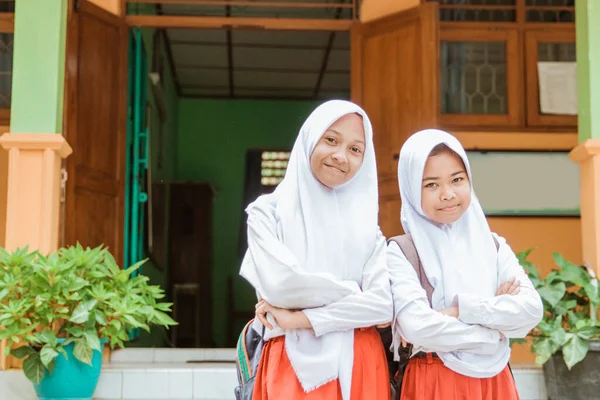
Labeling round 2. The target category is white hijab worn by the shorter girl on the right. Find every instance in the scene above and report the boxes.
[398,129,510,373]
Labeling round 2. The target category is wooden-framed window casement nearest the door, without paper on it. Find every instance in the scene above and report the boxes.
[440,29,520,126]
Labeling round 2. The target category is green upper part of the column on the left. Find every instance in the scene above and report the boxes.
[10,0,68,133]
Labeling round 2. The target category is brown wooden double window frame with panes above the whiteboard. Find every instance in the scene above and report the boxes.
[437,0,577,129]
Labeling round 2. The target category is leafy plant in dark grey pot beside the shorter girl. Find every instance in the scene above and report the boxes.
[517,250,600,400]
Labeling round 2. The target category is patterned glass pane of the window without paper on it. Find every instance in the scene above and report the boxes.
[440,41,507,114]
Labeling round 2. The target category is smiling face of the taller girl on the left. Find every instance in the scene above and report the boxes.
[310,114,365,188]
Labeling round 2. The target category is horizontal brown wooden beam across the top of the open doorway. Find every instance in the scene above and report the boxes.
[125,15,354,32]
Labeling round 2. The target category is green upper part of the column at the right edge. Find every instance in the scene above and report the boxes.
[575,0,600,143]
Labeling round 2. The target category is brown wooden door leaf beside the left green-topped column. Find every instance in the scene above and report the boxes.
[64,0,128,264]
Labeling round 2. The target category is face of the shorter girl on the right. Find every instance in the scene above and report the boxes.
[421,145,471,224]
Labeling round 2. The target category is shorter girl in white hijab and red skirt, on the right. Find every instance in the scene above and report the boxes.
[388,129,543,400]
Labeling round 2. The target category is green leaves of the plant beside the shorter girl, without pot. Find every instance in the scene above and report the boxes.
[517,249,600,369]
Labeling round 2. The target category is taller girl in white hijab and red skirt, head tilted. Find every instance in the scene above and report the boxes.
[240,100,392,400]
